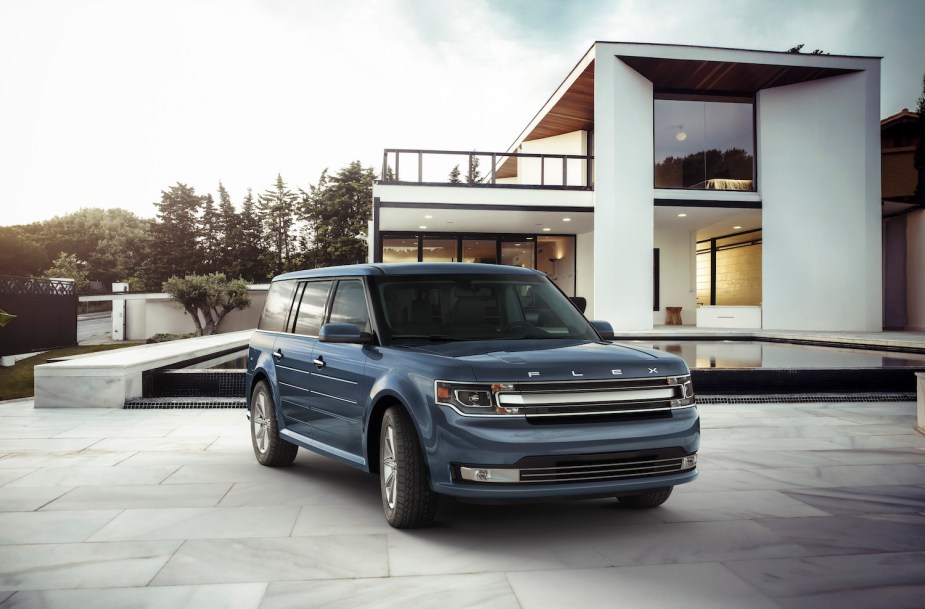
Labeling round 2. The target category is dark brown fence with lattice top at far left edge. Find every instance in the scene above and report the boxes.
[0,275,77,355]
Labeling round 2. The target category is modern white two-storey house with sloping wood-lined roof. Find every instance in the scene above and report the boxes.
[369,42,883,331]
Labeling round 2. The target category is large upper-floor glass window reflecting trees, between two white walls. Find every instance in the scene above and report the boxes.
[654,96,755,191]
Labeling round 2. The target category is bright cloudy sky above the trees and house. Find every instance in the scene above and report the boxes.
[0,0,925,226]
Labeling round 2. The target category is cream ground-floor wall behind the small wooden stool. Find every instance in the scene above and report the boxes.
[652,229,697,326]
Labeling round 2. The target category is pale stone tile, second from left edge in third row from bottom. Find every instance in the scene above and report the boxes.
[90,507,299,541]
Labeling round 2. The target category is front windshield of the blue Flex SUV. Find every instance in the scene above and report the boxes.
[374,275,598,341]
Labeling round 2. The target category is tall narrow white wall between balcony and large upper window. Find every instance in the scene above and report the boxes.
[594,50,654,330]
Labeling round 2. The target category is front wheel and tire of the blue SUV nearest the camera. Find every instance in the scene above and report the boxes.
[379,406,437,529]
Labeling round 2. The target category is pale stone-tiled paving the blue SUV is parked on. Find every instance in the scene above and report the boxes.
[0,401,925,609]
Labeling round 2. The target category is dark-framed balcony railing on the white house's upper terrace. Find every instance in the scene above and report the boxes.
[379,148,594,190]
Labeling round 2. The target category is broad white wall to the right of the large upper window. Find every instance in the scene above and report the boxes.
[757,67,882,331]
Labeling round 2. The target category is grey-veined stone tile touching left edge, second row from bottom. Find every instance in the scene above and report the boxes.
[0,541,180,590]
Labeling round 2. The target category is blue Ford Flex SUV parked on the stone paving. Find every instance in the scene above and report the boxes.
[247,263,700,528]
